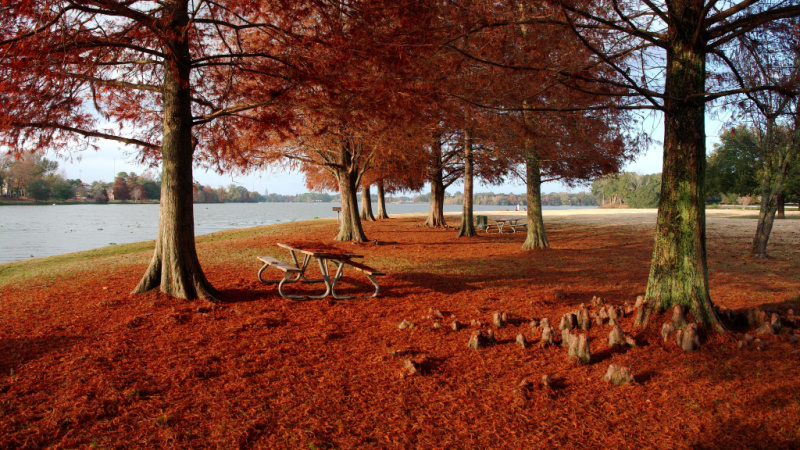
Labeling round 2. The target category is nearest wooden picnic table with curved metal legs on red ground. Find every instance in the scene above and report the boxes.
[257,243,386,299]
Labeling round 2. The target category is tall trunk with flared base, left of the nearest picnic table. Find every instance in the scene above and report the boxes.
[133,0,218,300]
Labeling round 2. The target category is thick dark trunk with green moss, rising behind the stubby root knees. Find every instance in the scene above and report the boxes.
[642,0,723,330]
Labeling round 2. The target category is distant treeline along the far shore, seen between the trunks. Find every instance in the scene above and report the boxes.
[0,151,800,210]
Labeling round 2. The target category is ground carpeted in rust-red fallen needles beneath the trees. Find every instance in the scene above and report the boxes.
[0,216,800,448]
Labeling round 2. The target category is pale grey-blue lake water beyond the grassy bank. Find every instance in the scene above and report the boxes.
[0,203,594,264]
